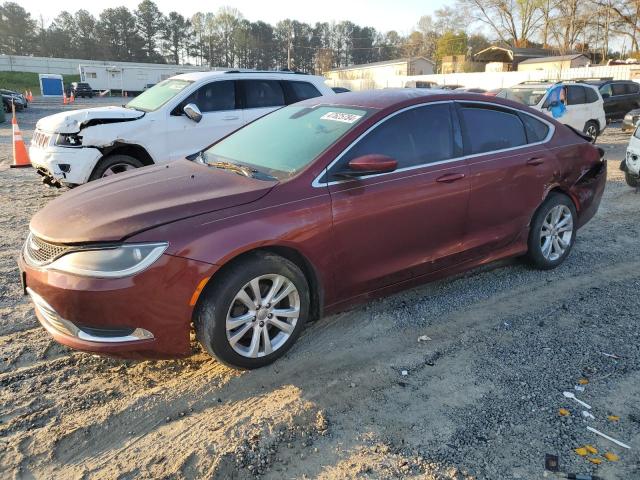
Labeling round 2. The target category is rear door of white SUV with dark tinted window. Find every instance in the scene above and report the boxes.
[238,78,286,124]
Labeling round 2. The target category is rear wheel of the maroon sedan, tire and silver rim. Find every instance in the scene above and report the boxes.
[527,192,578,270]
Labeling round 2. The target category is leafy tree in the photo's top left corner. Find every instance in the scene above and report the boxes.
[0,2,36,55]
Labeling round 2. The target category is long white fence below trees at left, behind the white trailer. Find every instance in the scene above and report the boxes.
[0,55,204,75]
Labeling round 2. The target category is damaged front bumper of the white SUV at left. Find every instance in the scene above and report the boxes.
[29,145,102,186]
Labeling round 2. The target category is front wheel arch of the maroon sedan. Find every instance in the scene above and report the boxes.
[194,245,324,322]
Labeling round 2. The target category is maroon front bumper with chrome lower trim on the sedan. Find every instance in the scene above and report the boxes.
[18,254,217,359]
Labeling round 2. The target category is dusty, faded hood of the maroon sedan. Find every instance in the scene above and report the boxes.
[30,160,278,244]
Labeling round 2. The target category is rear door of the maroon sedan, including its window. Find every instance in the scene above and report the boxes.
[458,102,558,258]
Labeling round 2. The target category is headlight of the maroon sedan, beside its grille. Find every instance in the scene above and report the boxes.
[48,242,169,278]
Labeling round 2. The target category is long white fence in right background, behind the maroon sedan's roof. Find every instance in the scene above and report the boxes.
[327,65,640,91]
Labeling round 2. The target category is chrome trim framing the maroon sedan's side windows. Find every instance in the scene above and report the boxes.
[311,100,556,188]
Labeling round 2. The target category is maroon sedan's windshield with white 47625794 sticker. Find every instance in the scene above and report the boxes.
[202,105,369,178]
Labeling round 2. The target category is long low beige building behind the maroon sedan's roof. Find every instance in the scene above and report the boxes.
[324,57,435,80]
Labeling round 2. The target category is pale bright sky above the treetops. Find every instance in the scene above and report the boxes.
[20,0,452,34]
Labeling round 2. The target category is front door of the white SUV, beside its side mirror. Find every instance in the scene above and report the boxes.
[166,80,242,160]
